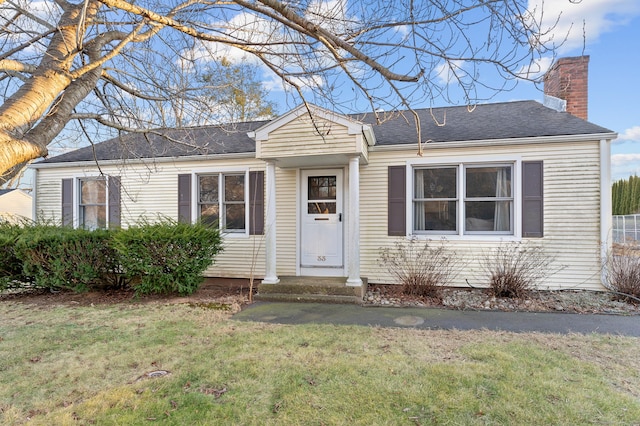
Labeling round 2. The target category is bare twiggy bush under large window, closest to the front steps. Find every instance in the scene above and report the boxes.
[379,238,461,298]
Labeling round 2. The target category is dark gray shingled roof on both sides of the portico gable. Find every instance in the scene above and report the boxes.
[40,101,612,164]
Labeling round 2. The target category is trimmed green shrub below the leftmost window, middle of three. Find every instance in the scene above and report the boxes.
[17,224,119,292]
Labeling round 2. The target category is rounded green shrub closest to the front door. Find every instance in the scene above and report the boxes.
[113,218,222,295]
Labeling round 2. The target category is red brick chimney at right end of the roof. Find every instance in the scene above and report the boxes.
[544,56,589,120]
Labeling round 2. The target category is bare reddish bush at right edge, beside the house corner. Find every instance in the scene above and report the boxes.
[605,243,640,305]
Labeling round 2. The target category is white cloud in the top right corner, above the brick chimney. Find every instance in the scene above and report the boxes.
[528,0,640,55]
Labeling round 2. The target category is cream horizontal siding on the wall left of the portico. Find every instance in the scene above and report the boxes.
[36,159,265,278]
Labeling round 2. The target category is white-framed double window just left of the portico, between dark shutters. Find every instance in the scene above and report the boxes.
[198,173,246,232]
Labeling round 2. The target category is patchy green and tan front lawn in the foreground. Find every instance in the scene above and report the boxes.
[0,302,640,425]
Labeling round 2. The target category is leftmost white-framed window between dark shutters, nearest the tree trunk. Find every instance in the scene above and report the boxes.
[78,177,107,229]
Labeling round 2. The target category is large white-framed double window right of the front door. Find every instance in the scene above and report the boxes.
[413,164,514,235]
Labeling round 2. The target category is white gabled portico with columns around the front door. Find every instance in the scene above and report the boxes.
[249,105,375,287]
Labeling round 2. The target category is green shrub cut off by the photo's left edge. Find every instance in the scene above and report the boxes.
[0,221,33,291]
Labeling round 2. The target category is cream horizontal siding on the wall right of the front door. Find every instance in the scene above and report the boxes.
[360,141,602,290]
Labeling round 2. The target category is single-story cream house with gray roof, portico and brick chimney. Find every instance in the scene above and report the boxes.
[28,57,616,290]
